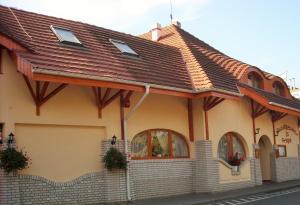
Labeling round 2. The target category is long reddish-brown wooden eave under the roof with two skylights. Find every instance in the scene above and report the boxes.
[0,34,240,100]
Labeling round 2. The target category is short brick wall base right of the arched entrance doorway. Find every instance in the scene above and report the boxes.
[271,156,300,182]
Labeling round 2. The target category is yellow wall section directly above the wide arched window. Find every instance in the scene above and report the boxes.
[125,94,194,156]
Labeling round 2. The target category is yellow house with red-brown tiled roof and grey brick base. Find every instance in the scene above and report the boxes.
[0,6,300,204]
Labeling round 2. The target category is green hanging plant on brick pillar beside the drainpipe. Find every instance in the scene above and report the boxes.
[103,147,127,171]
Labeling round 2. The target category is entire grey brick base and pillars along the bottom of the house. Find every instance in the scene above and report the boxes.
[0,140,300,205]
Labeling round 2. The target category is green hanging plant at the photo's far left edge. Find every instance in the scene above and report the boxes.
[0,148,29,174]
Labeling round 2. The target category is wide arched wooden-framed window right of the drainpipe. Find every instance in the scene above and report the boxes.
[131,129,189,159]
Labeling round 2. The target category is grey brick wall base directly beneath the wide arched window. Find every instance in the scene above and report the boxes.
[130,159,193,199]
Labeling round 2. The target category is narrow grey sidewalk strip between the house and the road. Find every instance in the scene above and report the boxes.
[127,180,300,205]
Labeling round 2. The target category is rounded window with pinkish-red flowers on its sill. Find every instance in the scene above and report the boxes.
[218,132,246,166]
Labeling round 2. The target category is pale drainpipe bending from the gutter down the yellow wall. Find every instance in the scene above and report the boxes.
[123,85,150,201]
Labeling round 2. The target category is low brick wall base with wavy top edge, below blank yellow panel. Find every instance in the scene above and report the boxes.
[18,172,105,204]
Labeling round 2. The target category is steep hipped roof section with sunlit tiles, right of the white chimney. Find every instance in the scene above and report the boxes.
[140,25,252,92]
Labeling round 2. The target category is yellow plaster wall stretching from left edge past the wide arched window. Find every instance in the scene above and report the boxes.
[0,52,193,181]
